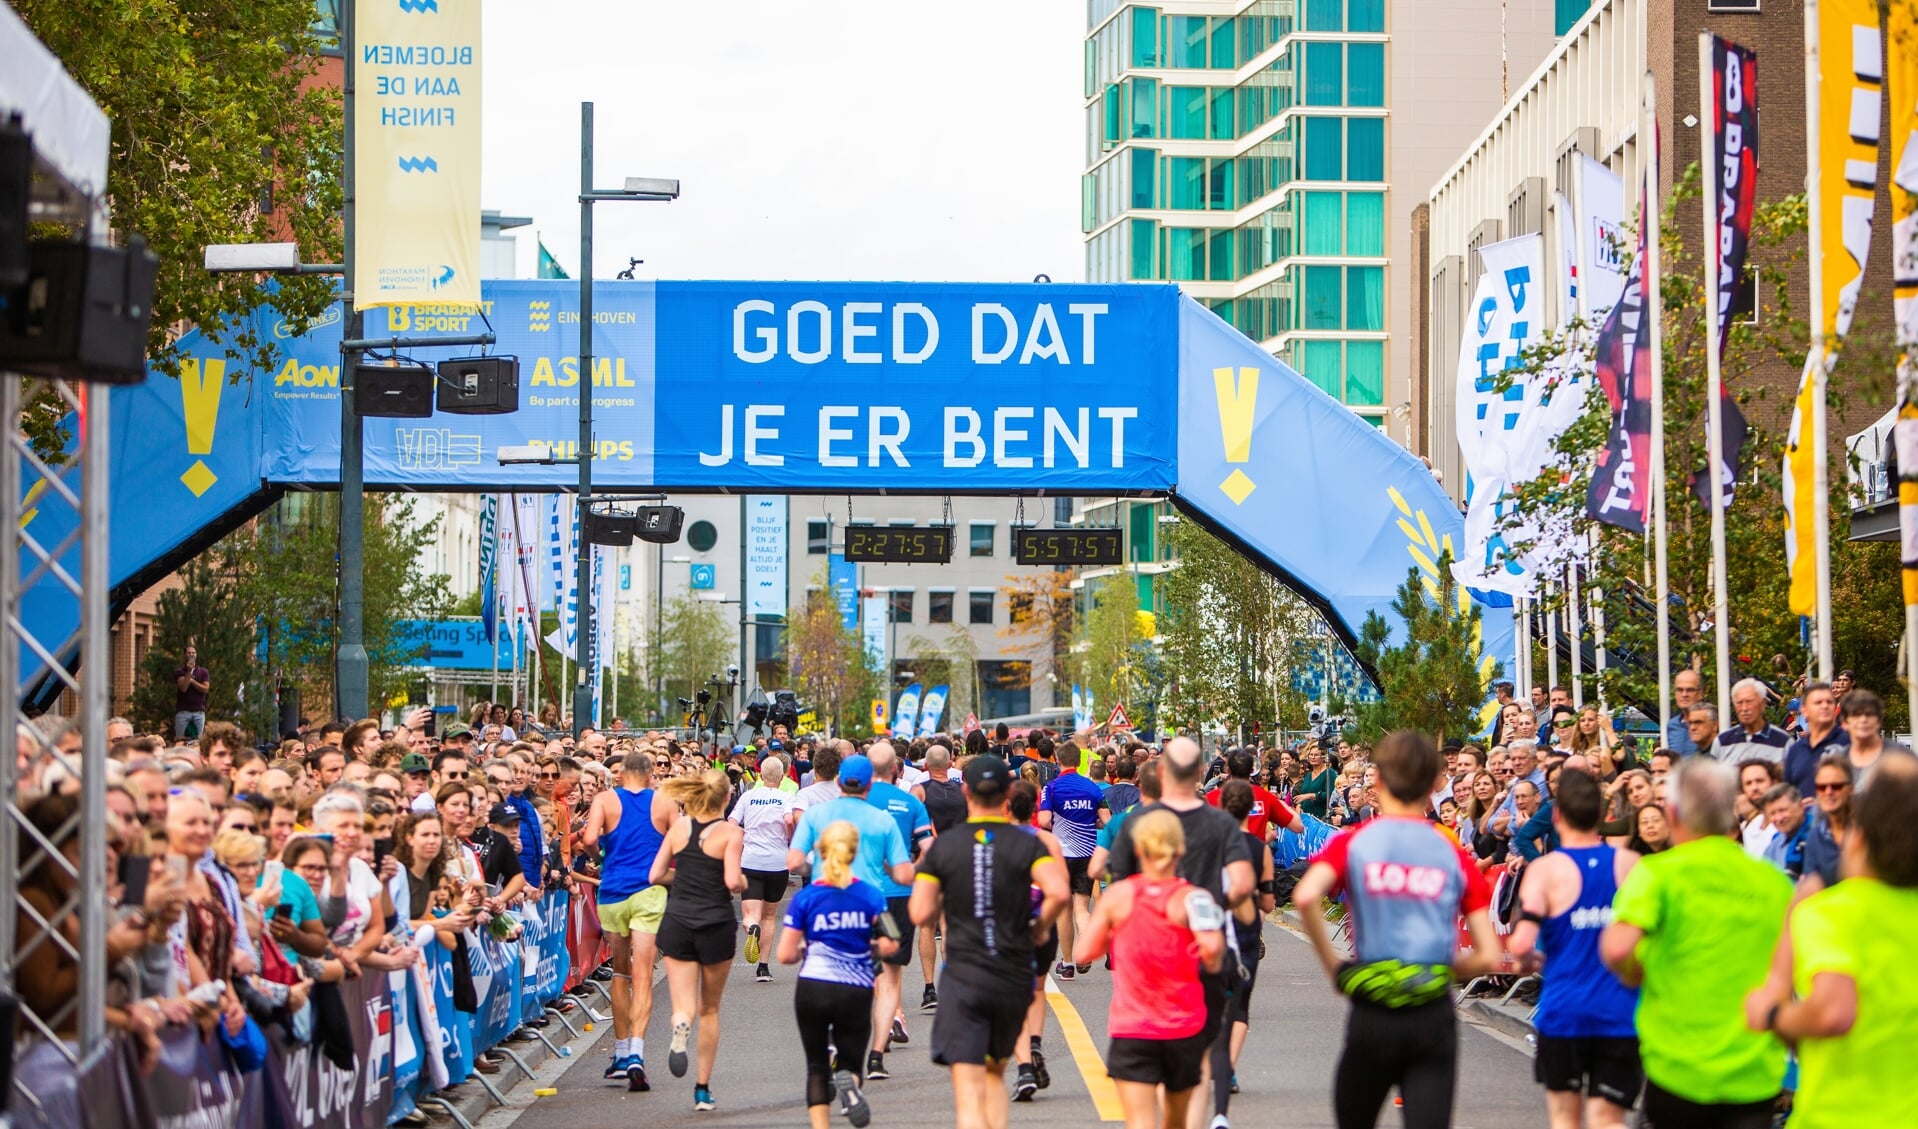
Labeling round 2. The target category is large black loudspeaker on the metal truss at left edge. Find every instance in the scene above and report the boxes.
[0,238,159,383]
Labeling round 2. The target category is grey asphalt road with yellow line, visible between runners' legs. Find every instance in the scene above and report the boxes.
[481,924,1544,1129]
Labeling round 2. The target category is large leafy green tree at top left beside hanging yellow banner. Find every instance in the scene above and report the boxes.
[13,0,343,380]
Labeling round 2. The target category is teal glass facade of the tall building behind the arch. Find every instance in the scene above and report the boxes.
[1080,0,1391,416]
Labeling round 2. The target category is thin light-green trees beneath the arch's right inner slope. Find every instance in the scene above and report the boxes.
[1160,521,1323,732]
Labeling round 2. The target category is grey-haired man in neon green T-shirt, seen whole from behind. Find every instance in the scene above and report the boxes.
[1600,757,1791,1129]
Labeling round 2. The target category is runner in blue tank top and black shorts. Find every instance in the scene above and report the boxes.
[1509,761,1644,1129]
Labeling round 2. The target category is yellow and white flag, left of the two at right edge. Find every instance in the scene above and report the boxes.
[1784,0,1897,615]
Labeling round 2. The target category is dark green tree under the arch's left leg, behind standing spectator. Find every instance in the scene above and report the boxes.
[129,558,258,734]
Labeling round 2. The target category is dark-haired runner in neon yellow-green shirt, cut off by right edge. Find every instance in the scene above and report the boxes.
[1745,759,1918,1129]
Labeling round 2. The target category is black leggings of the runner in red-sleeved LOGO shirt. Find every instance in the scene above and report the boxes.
[1331,997,1458,1129]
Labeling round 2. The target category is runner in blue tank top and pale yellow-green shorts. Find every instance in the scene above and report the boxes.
[585,753,673,1091]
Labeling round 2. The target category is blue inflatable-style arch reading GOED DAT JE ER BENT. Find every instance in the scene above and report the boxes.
[23,280,1513,705]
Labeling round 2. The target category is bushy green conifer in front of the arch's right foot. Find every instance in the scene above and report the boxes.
[1354,554,1504,740]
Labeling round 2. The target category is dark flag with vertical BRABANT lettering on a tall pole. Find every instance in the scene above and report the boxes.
[1694,35,1759,506]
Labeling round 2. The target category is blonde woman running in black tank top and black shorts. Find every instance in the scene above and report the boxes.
[652,771,746,1110]
